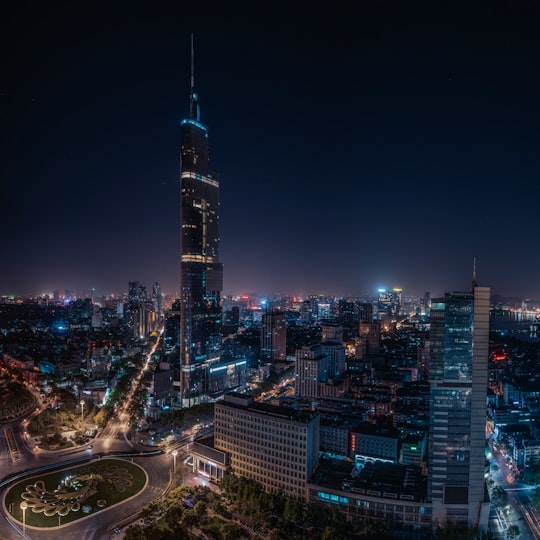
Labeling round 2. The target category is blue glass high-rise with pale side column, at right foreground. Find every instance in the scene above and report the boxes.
[428,282,490,528]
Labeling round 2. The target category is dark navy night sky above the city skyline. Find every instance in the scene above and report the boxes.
[0,1,540,299]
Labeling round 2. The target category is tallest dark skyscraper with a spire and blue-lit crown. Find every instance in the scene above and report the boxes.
[178,37,223,406]
